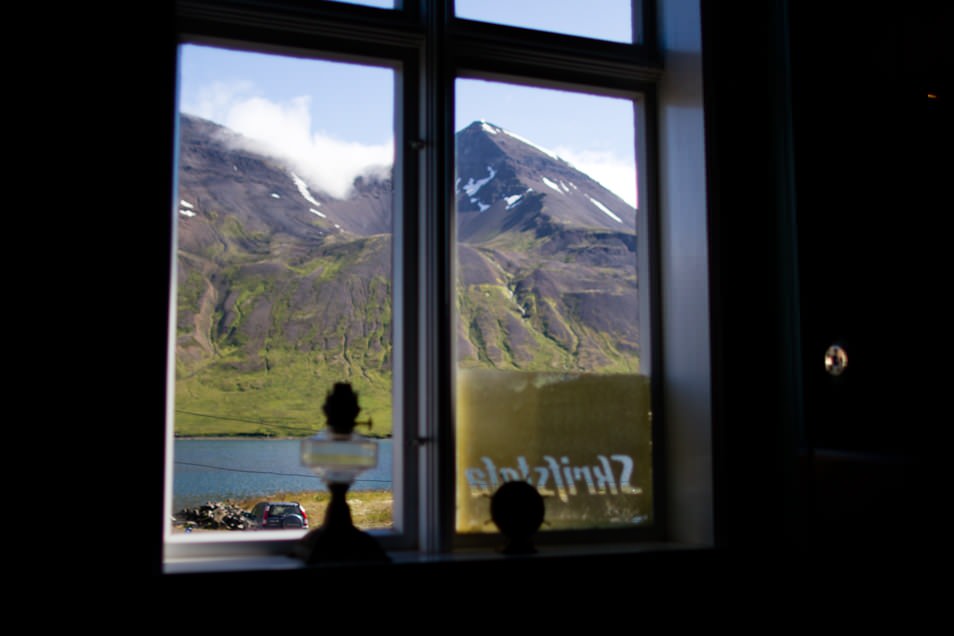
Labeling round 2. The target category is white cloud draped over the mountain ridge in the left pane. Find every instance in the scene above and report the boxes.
[183,83,394,198]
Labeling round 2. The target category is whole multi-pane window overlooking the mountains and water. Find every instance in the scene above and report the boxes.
[166,0,711,563]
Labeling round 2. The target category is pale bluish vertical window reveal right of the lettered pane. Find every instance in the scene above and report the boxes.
[658,0,715,545]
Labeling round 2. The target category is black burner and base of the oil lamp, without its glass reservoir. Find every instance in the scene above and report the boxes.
[294,382,391,565]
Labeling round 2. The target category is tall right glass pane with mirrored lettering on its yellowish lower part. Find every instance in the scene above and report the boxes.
[456,79,653,533]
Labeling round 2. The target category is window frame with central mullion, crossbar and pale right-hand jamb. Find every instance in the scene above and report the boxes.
[163,0,714,573]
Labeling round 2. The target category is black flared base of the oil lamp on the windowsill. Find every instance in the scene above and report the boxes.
[295,484,391,565]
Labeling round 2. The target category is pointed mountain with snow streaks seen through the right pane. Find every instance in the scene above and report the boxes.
[456,122,639,371]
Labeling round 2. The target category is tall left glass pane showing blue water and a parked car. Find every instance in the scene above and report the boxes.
[167,45,395,535]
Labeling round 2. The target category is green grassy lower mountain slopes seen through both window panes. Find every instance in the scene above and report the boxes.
[175,211,638,437]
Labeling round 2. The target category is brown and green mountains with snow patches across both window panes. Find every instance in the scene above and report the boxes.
[176,115,639,434]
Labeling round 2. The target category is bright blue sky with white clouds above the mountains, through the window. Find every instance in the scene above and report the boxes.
[179,0,637,207]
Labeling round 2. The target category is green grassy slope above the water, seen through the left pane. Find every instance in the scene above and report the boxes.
[175,232,391,437]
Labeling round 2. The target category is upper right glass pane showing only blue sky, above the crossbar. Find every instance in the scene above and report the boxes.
[454,0,633,43]
